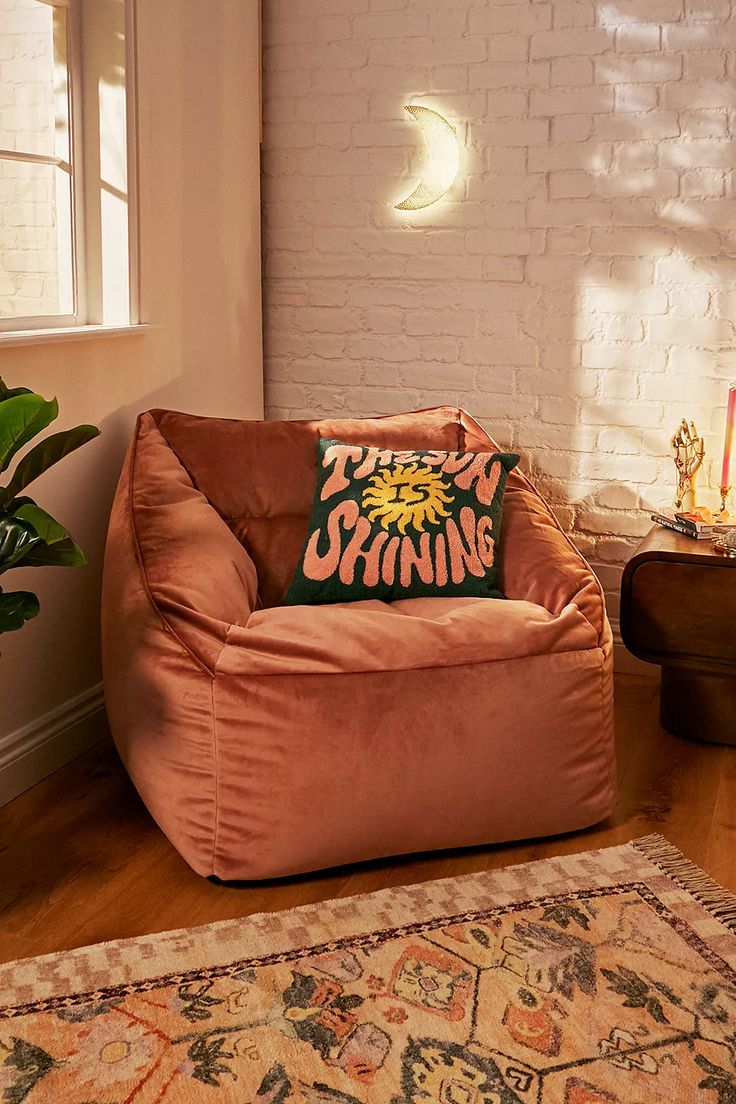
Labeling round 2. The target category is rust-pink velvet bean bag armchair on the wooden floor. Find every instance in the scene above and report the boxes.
[103,407,616,879]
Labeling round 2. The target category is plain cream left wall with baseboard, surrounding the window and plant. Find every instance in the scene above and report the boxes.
[0,0,263,804]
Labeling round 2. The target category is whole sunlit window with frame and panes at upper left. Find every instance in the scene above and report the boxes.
[0,0,137,331]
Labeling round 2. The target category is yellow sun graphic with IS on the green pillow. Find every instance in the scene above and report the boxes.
[362,464,454,535]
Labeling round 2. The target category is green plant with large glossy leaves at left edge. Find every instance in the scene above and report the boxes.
[0,378,99,633]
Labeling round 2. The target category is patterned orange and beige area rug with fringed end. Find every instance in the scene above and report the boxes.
[0,836,736,1104]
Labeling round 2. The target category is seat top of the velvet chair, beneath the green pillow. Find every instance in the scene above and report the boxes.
[218,597,598,675]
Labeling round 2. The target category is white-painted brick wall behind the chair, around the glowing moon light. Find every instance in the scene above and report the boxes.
[264,0,736,617]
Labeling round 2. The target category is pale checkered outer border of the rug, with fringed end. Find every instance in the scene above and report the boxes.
[0,835,736,1020]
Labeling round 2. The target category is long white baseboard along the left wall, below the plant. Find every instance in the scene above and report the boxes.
[0,682,107,805]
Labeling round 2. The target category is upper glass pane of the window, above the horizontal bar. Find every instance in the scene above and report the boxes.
[0,0,70,161]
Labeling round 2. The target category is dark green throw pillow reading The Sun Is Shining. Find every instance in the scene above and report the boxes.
[286,438,519,605]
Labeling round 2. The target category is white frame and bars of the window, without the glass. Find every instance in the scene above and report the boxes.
[0,0,141,333]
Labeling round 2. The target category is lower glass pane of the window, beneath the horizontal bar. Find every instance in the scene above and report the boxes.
[0,158,74,318]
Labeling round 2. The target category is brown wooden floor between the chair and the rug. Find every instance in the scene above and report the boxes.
[0,676,736,962]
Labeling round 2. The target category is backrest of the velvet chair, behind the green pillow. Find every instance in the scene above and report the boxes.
[150,406,481,606]
